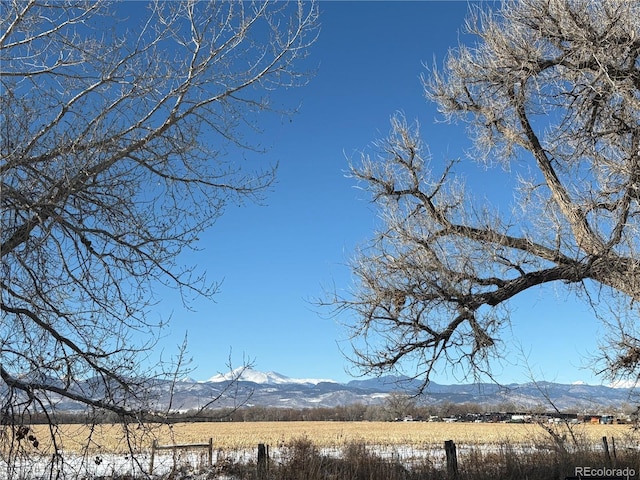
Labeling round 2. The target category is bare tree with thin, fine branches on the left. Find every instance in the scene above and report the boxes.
[0,0,318,472]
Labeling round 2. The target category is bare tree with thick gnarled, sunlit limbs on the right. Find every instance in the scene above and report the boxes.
[338,0,640,390]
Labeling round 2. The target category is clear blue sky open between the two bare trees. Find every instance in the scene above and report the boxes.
[152,1,601,383]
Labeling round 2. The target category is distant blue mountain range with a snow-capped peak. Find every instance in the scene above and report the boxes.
[158,369,638,411]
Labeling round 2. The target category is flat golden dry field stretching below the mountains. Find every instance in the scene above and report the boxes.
[26,422,638,453]
